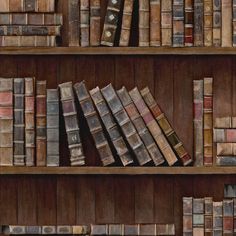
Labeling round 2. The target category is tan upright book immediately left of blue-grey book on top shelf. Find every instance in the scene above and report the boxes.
[161,0,172,46]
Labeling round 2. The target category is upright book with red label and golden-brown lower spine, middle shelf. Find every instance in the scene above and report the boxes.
[203,78,213,166]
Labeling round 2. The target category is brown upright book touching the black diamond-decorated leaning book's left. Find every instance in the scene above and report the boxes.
[90,0,101,46]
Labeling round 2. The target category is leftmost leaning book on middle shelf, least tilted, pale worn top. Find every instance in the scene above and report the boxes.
[59,82,85,166]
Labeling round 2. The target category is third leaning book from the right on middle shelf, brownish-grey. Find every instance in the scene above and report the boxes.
[117,86,165,166]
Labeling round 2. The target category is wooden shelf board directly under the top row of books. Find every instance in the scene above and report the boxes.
[0,47,236,55]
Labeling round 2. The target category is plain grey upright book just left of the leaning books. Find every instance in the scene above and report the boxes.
[47,89,60,166]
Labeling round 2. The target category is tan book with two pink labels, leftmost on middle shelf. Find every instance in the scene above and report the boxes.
[0,78,13,166]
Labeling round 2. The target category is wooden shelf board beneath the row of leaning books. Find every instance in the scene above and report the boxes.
[0,167,236,175]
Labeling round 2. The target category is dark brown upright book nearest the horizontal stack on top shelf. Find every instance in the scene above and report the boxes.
[68,0,80,46]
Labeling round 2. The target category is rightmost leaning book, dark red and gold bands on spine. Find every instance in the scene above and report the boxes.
[141,87,192,166]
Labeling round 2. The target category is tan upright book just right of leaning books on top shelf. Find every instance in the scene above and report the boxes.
[139,0,150,47]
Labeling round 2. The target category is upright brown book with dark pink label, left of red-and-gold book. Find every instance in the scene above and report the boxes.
[193,80,203,166]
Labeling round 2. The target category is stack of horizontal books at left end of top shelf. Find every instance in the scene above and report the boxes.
[0,0,63,47]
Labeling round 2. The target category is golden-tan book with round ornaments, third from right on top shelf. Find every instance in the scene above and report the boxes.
[204,0,213,47]
